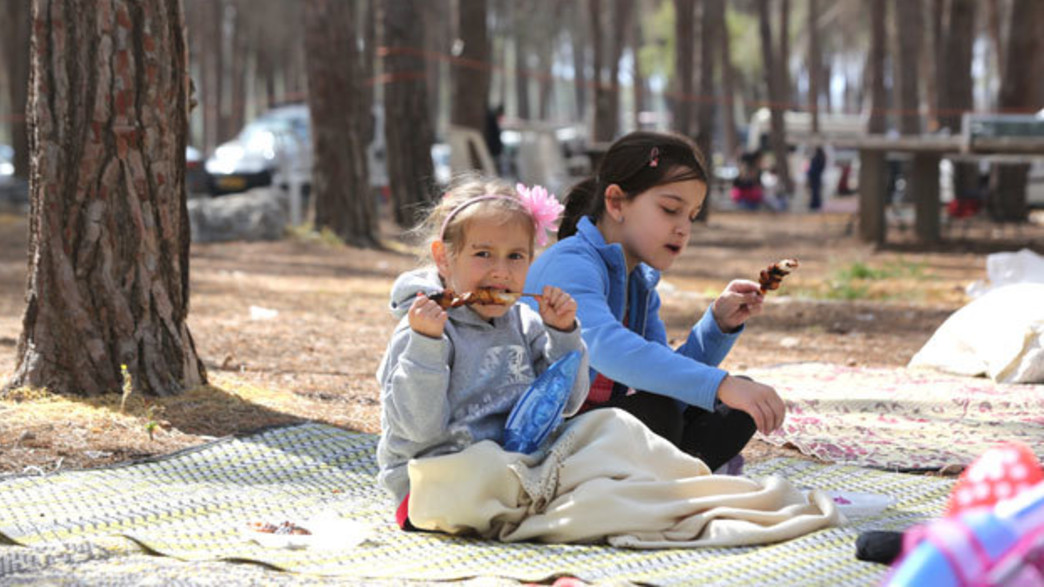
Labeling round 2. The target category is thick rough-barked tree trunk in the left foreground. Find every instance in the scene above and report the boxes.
[9,0,207,395]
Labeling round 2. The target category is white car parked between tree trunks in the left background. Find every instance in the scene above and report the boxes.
[205,104,312,195]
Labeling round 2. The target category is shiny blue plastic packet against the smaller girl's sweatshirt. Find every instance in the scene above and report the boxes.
[504,351,580,453]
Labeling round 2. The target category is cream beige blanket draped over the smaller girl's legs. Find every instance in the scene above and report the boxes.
[409,409,844,548]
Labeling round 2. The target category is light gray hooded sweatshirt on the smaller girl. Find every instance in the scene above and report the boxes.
[377,268,589,503]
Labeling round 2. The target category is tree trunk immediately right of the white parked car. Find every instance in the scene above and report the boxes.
[304,0,377,246]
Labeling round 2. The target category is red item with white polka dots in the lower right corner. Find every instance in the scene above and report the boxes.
[946,442,1044,516]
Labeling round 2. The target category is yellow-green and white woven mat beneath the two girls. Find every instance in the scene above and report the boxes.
[0,424,951,585]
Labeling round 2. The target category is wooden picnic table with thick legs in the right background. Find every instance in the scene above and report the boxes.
[834,115,1044,244]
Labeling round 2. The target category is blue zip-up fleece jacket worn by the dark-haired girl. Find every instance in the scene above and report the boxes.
[525,217,742,409]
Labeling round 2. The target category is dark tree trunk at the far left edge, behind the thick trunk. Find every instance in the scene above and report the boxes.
[0,0,29,179]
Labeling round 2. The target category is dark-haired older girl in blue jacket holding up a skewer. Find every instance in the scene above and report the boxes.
[525,132,785,470]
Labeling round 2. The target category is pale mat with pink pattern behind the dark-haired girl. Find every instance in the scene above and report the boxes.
[748,363,1044,470]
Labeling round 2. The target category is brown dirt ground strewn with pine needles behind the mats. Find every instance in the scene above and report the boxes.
[0,204,1044,475]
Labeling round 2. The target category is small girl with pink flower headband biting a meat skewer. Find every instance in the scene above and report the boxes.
[377,178,589,529]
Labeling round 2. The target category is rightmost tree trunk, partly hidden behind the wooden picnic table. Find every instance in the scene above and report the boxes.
[991,0,1044,221]
